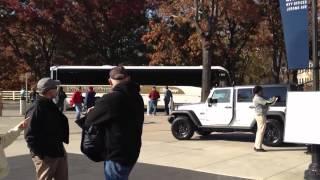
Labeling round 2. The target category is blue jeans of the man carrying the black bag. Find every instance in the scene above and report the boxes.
[104,160,133,180]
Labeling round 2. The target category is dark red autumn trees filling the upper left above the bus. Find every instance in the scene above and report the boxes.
[0,0,146,89]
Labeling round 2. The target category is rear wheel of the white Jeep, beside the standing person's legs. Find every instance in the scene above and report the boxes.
[263,119,283,146]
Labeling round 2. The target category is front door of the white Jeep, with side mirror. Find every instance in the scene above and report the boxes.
[206,88,233,126]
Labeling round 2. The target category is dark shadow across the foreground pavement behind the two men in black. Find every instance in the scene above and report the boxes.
[6,154,248,180]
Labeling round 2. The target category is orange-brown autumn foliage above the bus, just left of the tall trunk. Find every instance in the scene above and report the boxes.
[142,16,201,65]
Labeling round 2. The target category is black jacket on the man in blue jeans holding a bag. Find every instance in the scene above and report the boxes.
[85,82,144,165]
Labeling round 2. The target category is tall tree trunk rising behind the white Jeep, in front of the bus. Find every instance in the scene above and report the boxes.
[201,38,212,102]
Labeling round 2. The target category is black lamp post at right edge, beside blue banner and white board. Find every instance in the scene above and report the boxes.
[304,0,320,180]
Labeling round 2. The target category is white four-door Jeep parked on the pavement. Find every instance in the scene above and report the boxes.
[169,85,290,146]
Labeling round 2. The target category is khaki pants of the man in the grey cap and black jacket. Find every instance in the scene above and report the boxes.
[32,156,68,180]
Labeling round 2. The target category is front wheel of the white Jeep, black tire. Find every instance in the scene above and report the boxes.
[171,117,194,140]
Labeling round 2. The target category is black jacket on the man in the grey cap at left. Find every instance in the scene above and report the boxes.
[25,96,69,158]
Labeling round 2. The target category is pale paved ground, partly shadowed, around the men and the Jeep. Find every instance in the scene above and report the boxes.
[0,103,310,180]
